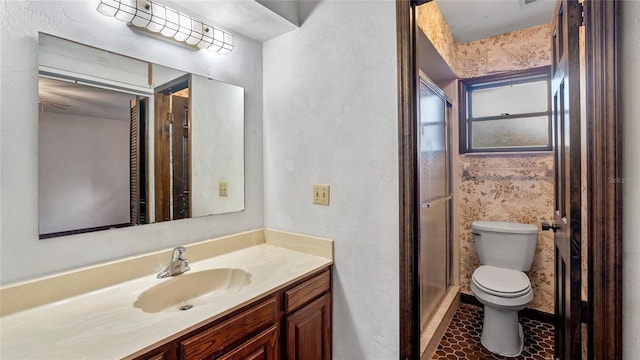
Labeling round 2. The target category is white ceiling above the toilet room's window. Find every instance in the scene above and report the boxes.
[435,0,556,44]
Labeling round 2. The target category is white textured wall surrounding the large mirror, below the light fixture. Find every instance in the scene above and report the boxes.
[0,1,263,284]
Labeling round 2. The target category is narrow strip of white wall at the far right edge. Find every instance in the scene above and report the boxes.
[620,0,640,360]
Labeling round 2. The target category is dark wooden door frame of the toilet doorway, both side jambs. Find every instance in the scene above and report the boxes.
[396,0,622,359]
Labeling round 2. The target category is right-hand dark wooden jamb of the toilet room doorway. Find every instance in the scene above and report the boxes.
[582,0,623,359]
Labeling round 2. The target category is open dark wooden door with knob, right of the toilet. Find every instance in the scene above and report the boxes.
[551,0,582,360]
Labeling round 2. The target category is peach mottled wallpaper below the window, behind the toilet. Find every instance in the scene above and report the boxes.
[458,153,554,313]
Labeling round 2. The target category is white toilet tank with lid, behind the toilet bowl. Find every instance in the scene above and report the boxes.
[471,221,538,271]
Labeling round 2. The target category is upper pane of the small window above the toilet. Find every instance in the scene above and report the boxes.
[471,81,548,118]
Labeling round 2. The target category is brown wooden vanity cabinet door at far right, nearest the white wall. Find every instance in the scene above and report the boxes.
[286,294,331,360]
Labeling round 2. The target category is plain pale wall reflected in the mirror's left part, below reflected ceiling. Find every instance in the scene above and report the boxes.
[38,114,131,234]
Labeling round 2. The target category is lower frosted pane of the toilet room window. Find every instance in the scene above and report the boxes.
[471,116,549,150]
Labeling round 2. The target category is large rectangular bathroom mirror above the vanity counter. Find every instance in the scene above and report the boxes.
[38,33,244,239]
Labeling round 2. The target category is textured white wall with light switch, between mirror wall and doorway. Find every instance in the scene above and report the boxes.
[263,0,399,360]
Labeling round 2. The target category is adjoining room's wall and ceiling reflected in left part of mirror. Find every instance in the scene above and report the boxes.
[38,76,146,235]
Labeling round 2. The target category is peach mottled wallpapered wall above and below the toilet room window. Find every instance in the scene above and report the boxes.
[417,2,554,313]
